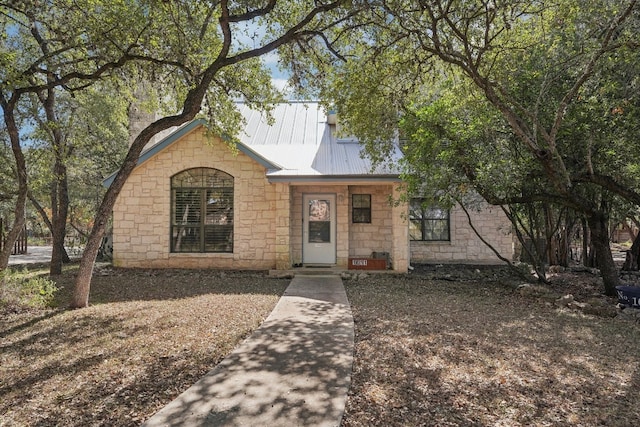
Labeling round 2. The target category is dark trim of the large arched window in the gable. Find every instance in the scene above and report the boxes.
[169,167,235,254]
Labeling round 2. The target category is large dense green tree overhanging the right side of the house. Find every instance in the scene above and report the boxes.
[300,0,640,295]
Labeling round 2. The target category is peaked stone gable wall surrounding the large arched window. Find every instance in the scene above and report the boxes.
[113,127,278,269]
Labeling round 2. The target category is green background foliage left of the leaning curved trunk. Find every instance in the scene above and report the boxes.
[25,81,128,239]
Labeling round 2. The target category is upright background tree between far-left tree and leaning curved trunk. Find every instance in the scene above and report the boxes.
[26,81,127,275]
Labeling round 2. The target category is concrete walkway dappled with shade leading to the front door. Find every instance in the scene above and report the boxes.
[144,276,354,427]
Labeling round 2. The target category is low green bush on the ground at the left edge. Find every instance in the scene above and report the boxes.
[0,269,58,309]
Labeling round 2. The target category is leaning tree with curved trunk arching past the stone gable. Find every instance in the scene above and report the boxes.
[71,0,355,308]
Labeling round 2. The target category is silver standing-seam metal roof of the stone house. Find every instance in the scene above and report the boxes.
[103,101,402,186]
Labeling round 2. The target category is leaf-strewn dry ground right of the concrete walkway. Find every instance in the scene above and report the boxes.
[343,266,640,427]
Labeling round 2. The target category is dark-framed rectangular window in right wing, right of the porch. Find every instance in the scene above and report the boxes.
[409,199,451,241]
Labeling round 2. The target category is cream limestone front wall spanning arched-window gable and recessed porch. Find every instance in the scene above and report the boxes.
[113,127,409,272]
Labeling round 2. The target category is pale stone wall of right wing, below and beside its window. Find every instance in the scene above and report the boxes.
[410,205,513,264]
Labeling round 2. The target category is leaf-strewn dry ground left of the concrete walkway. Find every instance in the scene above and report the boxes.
[0,269,289,426]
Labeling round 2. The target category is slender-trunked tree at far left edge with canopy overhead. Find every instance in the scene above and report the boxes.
[0,0,162,269]
